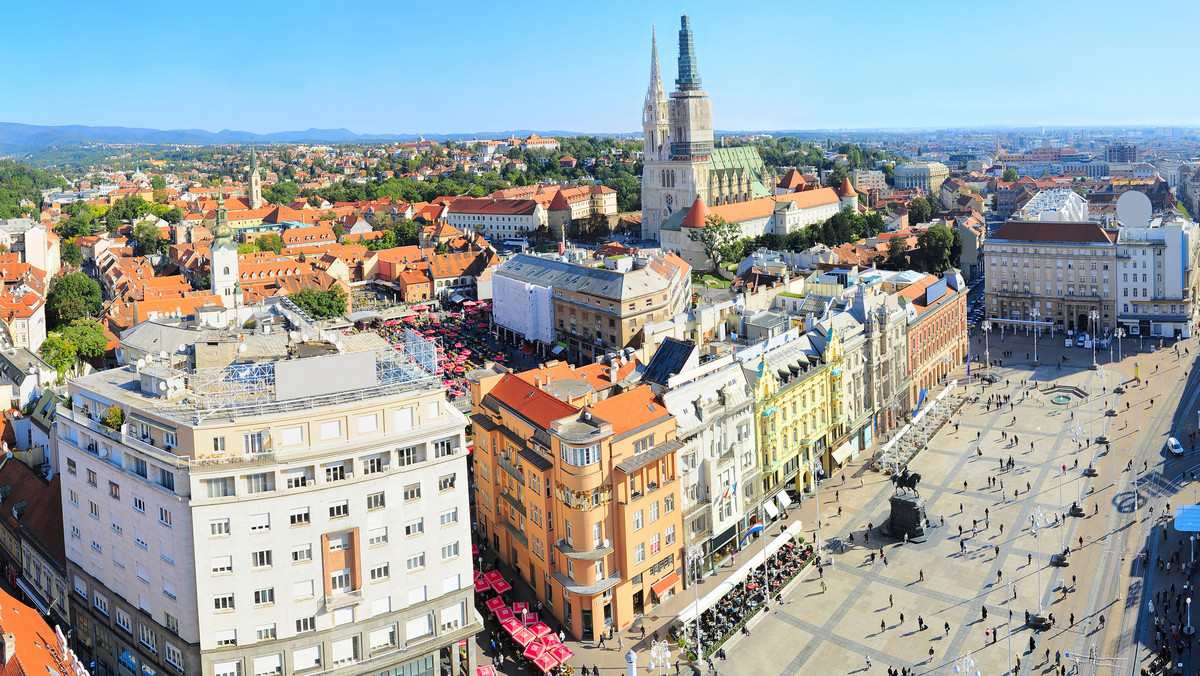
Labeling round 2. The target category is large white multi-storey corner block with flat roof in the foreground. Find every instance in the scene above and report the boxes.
[56,303,480,676]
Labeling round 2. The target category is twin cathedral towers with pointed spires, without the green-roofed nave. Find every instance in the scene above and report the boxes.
[642,14,713,239]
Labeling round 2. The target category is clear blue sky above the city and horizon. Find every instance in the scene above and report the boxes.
[9,0,1200,133]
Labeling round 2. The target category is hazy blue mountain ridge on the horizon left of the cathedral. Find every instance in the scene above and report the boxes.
[0,122,611,152]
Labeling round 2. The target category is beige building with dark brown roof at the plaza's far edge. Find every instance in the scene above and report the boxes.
[983,221,1117,331]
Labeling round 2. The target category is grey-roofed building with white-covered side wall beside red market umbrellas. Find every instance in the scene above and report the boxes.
[492,253,692,361]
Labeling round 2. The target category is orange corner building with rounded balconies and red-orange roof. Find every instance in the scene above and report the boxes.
[470,360,684,641]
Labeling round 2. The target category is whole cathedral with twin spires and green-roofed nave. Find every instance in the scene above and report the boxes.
[642,14,774,240]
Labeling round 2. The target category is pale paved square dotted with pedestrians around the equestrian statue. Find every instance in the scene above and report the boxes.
[481,333,1200,676]
